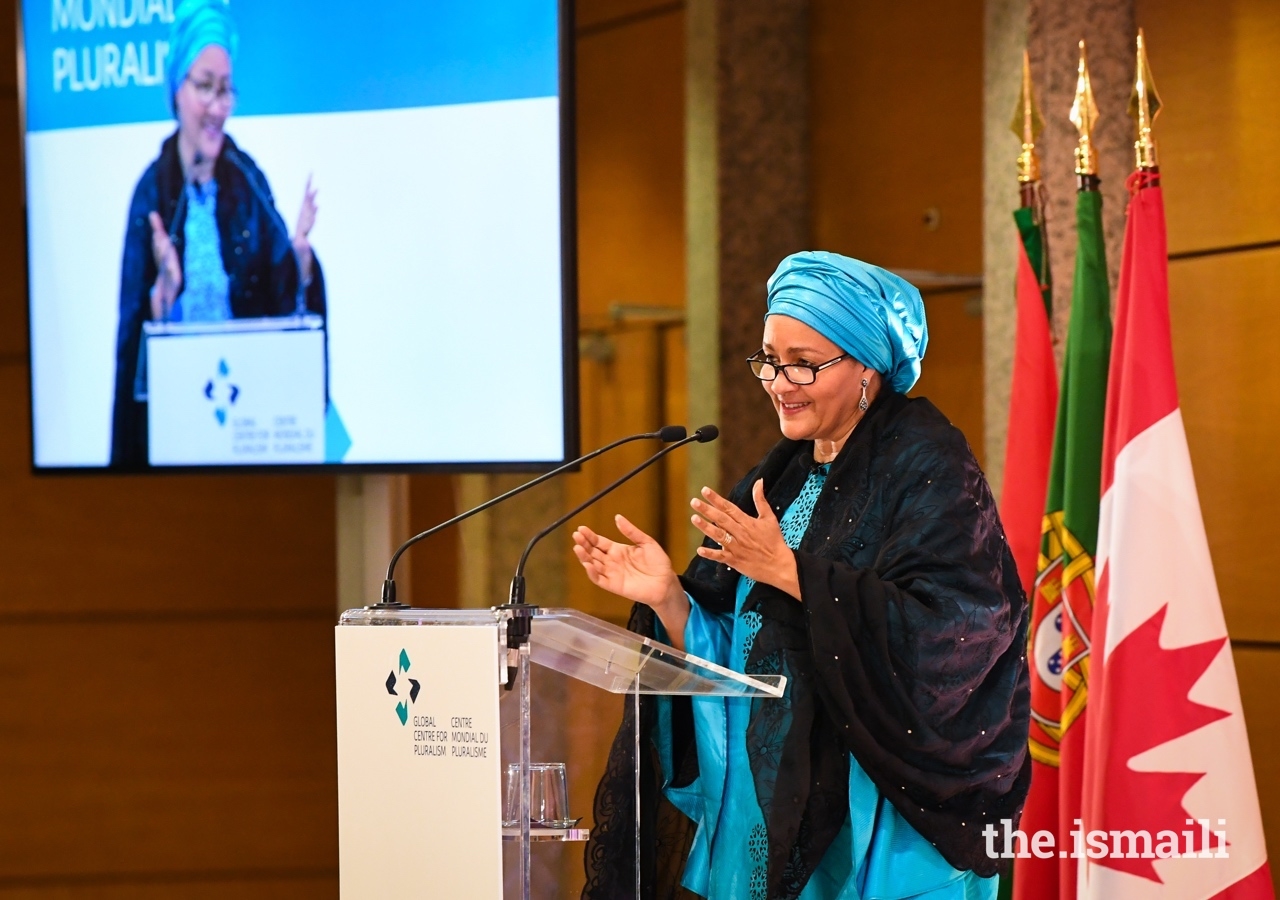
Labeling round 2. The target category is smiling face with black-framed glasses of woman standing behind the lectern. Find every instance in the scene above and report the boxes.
[760,315,874,442]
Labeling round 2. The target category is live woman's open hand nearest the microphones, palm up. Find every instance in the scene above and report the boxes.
[573,516,685,611]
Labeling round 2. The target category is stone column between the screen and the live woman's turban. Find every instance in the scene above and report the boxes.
[685,0,809,506]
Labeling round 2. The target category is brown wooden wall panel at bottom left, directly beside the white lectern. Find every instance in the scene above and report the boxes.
[0,613,338,886]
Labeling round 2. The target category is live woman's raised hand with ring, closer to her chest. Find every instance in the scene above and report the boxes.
[689,479,800,600]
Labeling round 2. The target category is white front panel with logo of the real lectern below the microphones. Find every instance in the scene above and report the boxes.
[335,621,502,900]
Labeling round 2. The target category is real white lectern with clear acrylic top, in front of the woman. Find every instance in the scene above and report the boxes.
[335,608,786,900]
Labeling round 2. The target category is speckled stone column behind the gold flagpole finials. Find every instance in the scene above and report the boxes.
[983,0,1138,494]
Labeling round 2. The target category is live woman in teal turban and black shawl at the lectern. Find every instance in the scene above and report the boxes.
[573,252,1030,900]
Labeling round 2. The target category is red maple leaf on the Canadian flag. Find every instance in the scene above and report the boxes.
[1088,606,1230,883]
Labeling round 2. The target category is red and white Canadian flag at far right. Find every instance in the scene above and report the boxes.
[1079,169,1275,900]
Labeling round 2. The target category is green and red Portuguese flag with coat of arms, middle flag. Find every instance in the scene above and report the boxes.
[1014,184,1111,900]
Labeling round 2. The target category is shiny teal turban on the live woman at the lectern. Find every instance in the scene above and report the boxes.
[764,251,929,393]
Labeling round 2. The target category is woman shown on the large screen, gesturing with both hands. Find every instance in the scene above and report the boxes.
[111,0,325,467]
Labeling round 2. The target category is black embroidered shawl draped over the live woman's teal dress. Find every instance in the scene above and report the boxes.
[582,390,1030,900]
